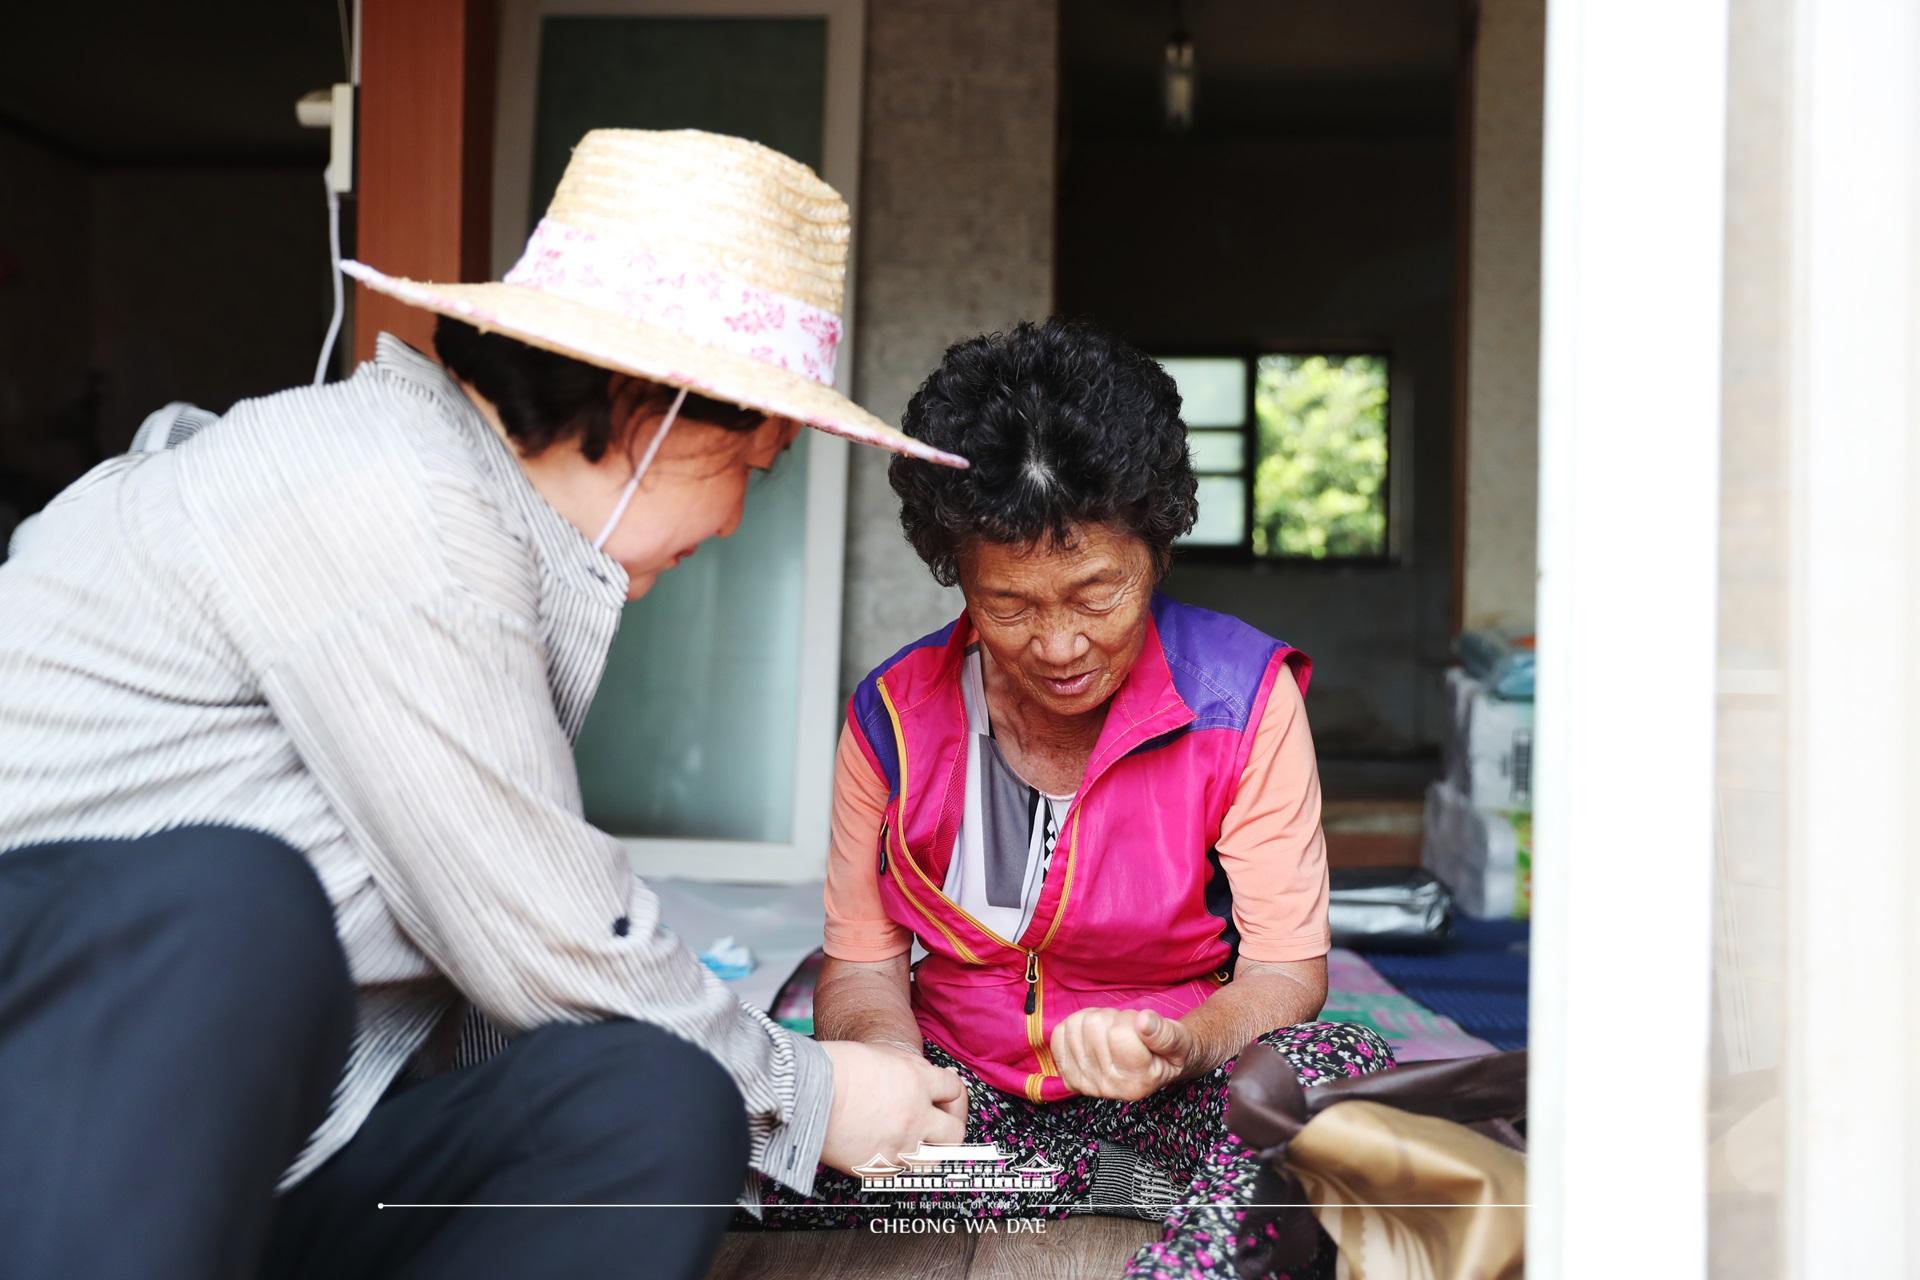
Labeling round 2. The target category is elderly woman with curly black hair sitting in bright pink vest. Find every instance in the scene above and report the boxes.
[752,320,1392,1276]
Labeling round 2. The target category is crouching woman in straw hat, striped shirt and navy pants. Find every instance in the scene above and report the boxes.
[0,130,964,1280]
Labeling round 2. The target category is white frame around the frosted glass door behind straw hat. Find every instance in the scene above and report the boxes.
[493,0,866,883]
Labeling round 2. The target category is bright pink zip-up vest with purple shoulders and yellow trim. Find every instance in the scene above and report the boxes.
[847,595,1311,1102]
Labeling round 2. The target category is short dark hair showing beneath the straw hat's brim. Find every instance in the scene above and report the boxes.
[434,317,770,462]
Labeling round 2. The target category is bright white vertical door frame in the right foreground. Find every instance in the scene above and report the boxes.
[1528,0,1728,1276]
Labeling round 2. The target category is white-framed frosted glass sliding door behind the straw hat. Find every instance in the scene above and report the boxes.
[493,0,862,881]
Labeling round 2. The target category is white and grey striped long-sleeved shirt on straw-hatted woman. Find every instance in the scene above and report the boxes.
[0,334,831,1201]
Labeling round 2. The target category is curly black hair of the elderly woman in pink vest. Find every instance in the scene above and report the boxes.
[887,319,1198,587]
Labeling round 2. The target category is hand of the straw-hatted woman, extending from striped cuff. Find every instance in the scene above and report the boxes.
[820,1040,966,1173]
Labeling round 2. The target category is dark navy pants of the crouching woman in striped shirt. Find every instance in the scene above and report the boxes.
[0,827,747,1280]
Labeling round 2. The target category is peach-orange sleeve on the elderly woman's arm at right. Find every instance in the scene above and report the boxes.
[1217,668,1332,961]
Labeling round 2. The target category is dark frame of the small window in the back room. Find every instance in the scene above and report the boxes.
[1148,338,1405,572]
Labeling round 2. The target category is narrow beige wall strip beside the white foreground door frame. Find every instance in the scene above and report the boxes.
[1461,0,1546,628]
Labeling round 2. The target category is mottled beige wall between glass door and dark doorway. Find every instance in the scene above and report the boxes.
[841,0,1058,691]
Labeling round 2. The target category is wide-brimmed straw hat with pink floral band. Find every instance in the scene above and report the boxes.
[342,129,966,466]
